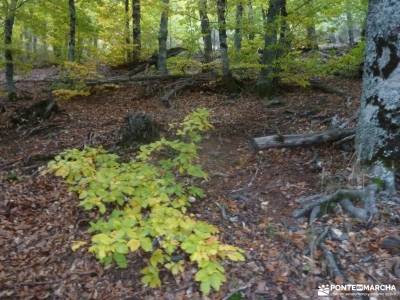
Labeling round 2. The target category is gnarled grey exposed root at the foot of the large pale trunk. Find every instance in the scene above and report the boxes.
[293,184,378,223]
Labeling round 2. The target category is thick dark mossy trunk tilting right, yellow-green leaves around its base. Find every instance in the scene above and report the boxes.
[257,0,282,97]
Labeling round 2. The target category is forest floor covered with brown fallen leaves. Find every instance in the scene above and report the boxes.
[0,71,400,299]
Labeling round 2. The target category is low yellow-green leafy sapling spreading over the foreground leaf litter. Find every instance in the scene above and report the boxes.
[48,109,244,294]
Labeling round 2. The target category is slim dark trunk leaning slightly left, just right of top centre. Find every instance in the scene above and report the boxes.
[217,0,232,81]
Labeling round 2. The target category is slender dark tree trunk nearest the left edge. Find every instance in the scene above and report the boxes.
[4,0,17,101]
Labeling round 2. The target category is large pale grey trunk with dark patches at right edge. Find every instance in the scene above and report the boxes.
[356,0,400,190]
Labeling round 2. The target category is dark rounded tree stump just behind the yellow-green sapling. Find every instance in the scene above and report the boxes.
[120,112,160,146]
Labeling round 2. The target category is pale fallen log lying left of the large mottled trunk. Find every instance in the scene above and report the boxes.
[251,128,355,150]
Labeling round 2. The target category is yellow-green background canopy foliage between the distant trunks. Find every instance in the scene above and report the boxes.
[0,0,367,77]
